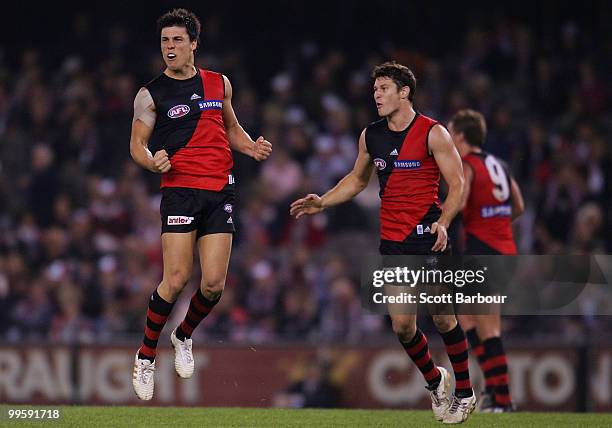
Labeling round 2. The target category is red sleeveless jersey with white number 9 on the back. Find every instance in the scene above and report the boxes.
[463,152,516,254]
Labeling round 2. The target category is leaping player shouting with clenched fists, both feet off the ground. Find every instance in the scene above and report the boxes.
[130,9,272,400]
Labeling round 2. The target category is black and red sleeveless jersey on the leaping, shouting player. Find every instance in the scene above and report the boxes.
[145,69,233,191]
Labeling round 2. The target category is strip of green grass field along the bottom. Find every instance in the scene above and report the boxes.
[0,405,612,428]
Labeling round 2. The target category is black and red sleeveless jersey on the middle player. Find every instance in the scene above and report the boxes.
[365,113,441,242]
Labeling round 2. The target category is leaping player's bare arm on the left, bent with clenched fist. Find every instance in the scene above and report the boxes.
[130,88,171,173]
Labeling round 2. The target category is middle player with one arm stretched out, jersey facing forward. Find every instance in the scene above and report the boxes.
[291,62,476,423]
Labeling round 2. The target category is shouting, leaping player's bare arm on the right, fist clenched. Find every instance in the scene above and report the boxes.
[223,76,272,161]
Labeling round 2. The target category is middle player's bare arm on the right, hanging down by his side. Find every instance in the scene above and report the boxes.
[429,125,465,251]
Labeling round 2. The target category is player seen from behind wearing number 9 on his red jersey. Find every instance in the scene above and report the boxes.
[448,109,524,413]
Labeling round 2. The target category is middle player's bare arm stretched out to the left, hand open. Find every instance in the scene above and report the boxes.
[290,130,374,219]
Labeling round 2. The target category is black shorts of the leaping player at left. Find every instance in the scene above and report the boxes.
[159,184,236,238]
